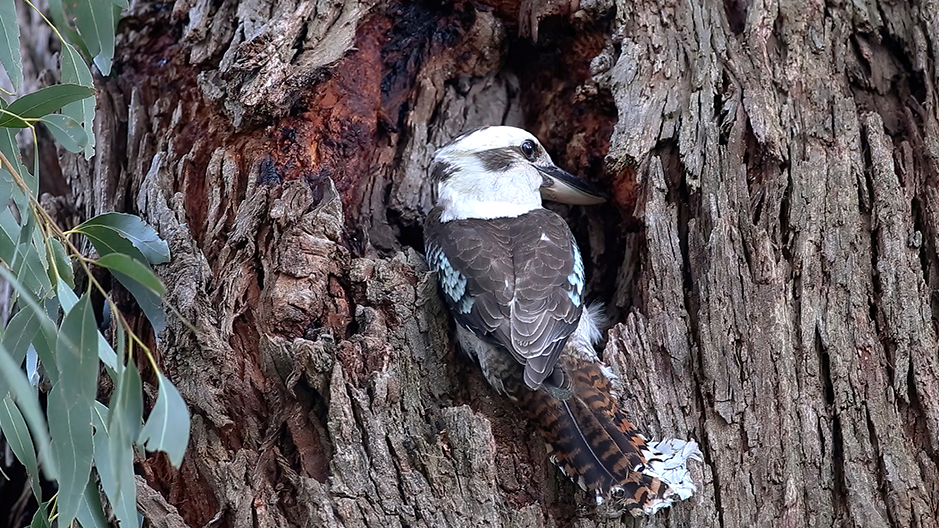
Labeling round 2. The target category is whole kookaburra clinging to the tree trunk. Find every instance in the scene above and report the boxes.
[424,126,698,515]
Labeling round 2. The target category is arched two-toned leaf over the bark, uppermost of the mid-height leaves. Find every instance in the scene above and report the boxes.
[74,213,170,264]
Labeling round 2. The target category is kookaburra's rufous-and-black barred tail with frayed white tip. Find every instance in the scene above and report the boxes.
[511,363,700,516]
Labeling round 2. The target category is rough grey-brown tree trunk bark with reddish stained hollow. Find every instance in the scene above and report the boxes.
[11,0,939,528]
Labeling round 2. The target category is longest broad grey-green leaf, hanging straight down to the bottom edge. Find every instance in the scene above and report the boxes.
[47,293,98,526]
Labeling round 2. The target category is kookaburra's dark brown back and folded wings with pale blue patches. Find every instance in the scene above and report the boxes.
[424,209,584,388]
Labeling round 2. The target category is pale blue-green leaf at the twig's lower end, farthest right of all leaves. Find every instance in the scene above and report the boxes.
[137,372,189,467]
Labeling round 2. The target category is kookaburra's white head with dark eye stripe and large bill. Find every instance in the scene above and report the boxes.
[431,126,606,222]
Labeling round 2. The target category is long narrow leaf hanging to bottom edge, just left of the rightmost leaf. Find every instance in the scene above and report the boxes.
[103,361,143,528]
